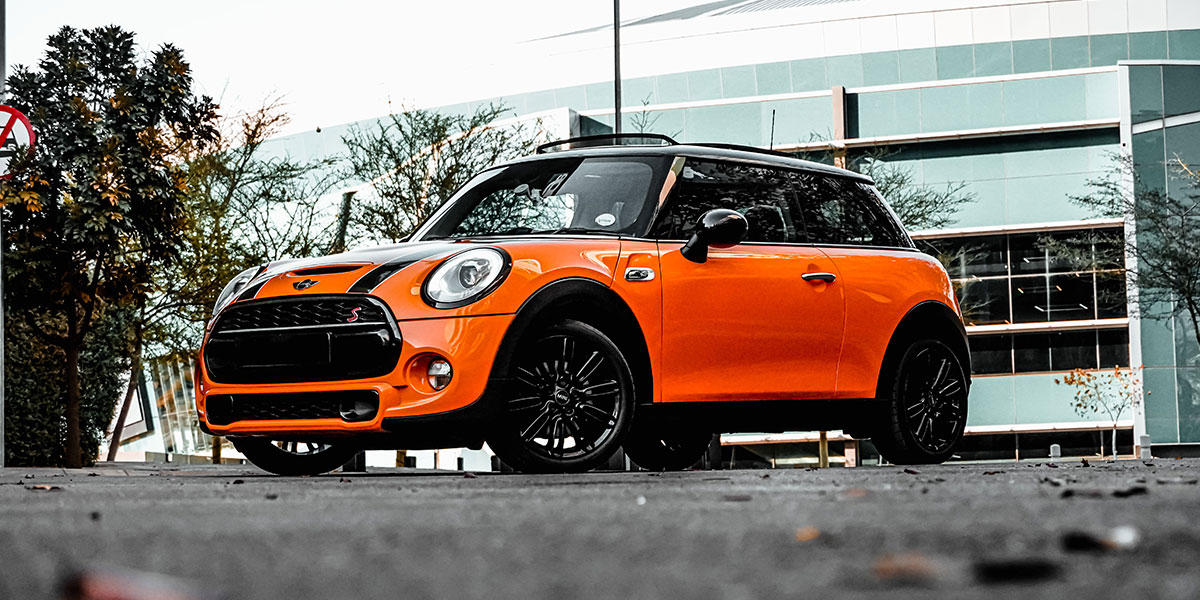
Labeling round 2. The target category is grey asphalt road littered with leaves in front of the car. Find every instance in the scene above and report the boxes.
[0,458,1200,599]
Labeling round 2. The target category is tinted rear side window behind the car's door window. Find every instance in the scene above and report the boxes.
[792,173,911,247]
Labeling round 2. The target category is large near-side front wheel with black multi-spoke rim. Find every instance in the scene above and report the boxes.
[488,320,635,473]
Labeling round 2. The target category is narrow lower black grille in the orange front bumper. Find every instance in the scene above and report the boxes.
[205,390,379,425]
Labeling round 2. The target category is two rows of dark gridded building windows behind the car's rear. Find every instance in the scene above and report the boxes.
[917,227,1129,374]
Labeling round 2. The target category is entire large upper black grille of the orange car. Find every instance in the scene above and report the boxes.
[204,295,401,384]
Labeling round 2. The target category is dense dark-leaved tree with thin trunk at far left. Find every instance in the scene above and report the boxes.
[0,26,216,467]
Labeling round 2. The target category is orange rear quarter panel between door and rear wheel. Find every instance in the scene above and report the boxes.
[822,247,959,398]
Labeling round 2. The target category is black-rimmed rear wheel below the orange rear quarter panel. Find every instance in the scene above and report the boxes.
[871,340,968,464]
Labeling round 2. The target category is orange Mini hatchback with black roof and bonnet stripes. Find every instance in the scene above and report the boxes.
[196,134,971,475]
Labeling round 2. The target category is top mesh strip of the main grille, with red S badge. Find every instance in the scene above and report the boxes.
[212,296,388,334]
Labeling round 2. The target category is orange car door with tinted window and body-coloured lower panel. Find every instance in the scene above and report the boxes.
[654,158,845,402]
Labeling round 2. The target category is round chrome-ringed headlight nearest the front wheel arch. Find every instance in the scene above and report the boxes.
[421,248,511,308]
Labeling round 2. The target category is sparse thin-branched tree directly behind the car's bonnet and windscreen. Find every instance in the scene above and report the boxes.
[342,104,533,242]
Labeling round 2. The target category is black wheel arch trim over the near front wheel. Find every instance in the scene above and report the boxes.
[488,277,654,403]
